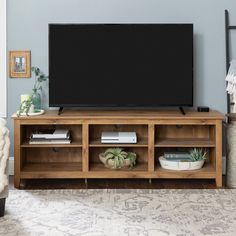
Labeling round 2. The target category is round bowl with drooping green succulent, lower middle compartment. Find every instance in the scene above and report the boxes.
[99,148,136,169]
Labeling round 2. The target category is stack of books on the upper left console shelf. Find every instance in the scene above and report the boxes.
[29,129,71,144]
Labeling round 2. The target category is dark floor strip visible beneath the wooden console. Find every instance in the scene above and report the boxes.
[10,176,225,190]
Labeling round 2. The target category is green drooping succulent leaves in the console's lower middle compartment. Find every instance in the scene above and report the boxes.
[103,148,136,169]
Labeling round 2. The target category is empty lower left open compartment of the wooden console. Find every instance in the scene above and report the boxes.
[21,147,82,178]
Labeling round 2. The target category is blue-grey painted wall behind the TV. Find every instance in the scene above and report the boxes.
[7,0,236,156]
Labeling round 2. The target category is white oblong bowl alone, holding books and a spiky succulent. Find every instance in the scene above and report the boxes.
[159,156,205,170]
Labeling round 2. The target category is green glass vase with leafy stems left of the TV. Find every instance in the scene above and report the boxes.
[31,67,48,112]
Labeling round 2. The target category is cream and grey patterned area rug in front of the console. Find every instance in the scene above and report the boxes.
[0,190,236,236]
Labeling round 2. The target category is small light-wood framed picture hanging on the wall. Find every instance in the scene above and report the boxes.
[9,51,31,78]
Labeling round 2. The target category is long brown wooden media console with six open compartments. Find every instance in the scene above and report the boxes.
[13,110,224,188]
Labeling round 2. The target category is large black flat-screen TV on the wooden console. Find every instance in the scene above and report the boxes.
[49,24,193,107]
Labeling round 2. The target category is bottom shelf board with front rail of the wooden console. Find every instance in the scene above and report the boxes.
[20,163,216,180]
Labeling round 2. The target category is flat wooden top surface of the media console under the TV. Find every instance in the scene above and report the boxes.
[12,110,224,120]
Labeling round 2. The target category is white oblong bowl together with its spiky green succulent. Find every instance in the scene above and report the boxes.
[159,148,207,170]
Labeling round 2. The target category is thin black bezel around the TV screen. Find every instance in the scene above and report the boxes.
[48,23,194,109]
